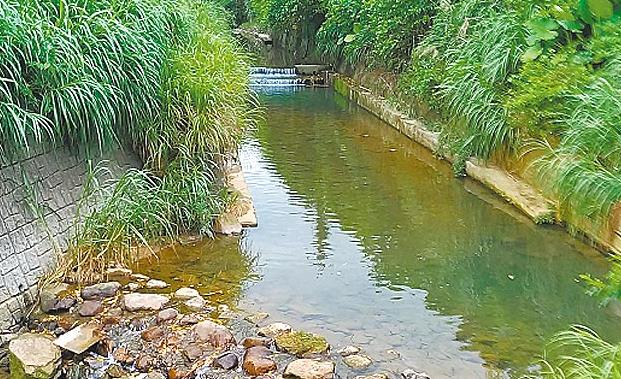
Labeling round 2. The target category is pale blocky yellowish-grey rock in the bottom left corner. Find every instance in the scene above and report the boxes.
[9,333,61,379]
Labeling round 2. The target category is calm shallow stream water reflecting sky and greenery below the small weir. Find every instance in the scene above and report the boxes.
[144,88,621,379]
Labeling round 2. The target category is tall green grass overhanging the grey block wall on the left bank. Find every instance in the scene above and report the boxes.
[0,0,252,280]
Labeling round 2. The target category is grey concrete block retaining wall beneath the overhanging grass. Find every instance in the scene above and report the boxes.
[0,150,139,342]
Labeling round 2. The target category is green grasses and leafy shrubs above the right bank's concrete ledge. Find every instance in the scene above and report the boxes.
[240,0,621,222]
